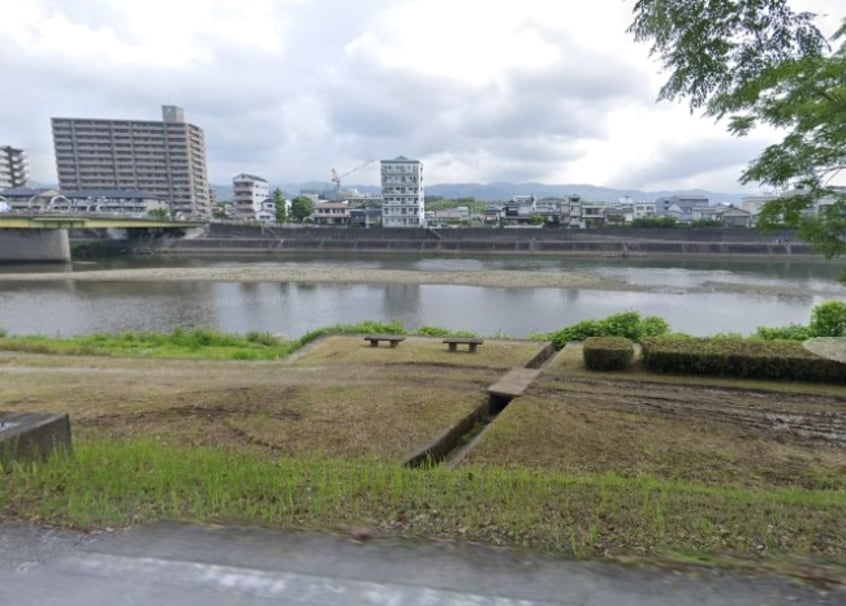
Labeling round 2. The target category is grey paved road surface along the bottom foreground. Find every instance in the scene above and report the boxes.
[0,524,846,606]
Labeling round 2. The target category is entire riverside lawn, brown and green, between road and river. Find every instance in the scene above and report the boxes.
[0,336,846,578]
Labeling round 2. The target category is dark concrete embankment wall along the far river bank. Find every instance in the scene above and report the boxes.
[126,224,813,257]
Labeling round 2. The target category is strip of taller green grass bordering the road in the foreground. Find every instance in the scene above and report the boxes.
[0,440,846,564]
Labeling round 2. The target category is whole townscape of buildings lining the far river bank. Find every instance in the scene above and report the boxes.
[0,105,833,229]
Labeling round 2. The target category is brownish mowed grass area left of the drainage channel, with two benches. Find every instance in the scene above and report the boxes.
[0,336,541,462]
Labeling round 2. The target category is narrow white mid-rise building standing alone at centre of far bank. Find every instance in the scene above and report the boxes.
[382,156,426,227]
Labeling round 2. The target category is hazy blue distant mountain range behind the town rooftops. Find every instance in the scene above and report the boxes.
[212,181,744,206]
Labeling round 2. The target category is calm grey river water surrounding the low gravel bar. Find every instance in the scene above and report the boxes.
[0,255,846,337]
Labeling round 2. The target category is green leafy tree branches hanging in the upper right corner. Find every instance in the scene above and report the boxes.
[629,0,846,279]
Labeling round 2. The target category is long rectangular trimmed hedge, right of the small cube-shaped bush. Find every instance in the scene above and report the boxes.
[641,337,846,384]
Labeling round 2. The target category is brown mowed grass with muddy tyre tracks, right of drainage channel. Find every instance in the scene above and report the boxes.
[463,346,846,490]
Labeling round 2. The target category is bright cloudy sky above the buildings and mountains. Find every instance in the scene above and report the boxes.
[0,0,846,192]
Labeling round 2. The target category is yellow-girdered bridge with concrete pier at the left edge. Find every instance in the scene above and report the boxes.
[0,213,205,263]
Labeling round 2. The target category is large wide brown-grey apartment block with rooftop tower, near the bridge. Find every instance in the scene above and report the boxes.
[52,105,211,216]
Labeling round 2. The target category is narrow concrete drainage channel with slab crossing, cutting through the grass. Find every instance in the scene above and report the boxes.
[404,343,556,467]
